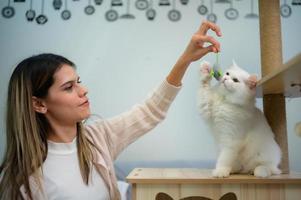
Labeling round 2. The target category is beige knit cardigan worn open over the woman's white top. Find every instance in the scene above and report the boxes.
[20,80,180,200]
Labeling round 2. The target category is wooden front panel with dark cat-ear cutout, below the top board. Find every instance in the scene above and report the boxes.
[133,184,301,200]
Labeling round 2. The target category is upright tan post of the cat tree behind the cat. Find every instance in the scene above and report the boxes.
[258,0,289,173]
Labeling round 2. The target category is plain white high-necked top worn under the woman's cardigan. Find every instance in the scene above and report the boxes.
[43,138,110,200]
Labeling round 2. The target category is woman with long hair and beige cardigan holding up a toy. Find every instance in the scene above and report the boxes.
[0,22,221,200]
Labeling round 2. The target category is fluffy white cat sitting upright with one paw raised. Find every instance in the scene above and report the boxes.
[198,61,281,177]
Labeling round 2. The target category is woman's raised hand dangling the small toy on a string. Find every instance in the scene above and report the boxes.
[181,21,222,63]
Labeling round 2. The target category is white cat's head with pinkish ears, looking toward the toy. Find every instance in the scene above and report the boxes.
[220,61,256,104]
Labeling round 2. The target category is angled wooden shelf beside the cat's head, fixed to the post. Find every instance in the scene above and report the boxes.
[256,53,301,98]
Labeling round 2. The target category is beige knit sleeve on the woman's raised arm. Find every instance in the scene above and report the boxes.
[86,80,181,160]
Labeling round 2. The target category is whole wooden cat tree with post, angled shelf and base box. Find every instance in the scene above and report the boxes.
[127,0,301,200]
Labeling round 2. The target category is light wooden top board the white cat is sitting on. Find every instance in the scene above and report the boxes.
[127,168,301,184]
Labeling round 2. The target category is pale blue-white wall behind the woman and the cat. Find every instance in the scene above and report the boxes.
[0,0,301,171]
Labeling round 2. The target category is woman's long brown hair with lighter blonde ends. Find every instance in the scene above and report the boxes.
[0,54,93,200]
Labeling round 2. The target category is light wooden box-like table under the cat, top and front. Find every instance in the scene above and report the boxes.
[127,168,301,200]
